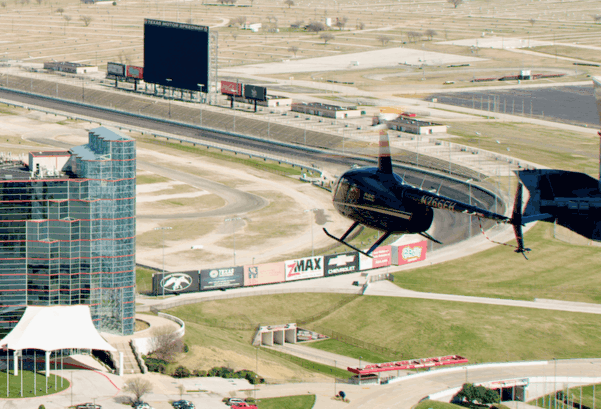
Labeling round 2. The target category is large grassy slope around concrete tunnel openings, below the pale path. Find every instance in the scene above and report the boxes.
[168,293,601,373]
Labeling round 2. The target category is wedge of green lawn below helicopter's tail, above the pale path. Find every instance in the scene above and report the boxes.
[394,222,601,303]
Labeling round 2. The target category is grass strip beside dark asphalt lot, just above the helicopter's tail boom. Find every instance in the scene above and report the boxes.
[448,122,599,177]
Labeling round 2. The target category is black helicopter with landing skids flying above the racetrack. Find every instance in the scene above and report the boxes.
[323,131,530,257]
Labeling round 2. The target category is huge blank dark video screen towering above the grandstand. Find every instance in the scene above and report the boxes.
[144,19,209,92]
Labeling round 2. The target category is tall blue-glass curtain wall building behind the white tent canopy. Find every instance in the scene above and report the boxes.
[0,127,136,336]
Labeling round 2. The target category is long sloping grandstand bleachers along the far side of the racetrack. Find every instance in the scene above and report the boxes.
[0,75,482,180]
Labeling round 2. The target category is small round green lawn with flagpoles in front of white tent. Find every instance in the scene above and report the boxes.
[0,371,69,399]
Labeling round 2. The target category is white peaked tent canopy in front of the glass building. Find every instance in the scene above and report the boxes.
[0,305,116,351]
